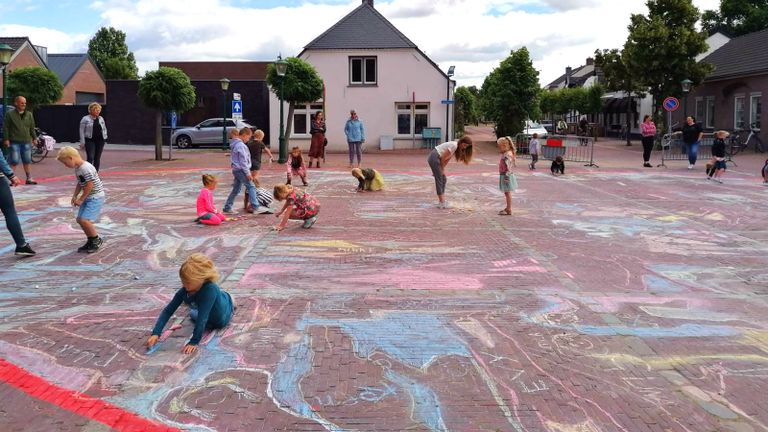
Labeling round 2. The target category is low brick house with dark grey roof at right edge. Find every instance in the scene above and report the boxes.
[675,29,768,141]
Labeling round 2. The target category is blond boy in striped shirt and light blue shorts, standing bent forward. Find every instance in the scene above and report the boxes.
[56,146,107,253]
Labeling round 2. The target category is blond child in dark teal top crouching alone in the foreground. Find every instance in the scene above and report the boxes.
[147,253,235,354]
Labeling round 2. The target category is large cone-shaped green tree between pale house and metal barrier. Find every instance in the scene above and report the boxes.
[480,47,540,137]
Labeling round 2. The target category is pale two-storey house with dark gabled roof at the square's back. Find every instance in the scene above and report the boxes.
[270,0,455,151]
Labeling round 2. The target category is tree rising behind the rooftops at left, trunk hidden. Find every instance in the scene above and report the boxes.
[88,27,139,79]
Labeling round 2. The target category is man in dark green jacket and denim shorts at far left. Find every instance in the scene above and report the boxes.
[3,96,37,184]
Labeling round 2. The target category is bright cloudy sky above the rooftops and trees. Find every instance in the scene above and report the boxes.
[0,0,719,86]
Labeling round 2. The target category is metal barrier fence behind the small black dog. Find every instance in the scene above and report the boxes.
[515,134,599,168]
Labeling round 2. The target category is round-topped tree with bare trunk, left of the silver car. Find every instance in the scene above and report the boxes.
[139,67,196,160]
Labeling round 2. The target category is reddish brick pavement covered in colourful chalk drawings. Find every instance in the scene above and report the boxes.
[0,130,768,432]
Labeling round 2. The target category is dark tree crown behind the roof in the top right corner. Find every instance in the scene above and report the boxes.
[701,0,768,36]
